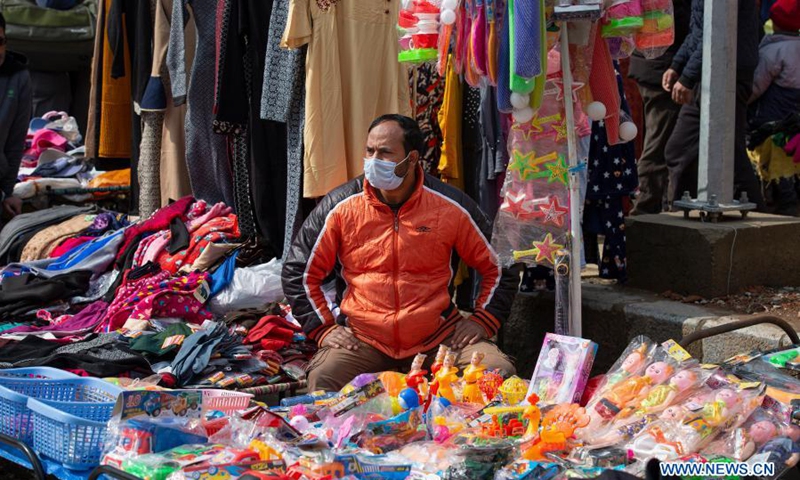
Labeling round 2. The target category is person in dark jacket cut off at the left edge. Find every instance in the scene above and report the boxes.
[0,13,31,217]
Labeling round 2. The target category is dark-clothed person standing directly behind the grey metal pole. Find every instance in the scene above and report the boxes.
[662,0,764,210]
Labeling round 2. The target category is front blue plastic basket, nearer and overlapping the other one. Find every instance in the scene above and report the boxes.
[28,378,122,470]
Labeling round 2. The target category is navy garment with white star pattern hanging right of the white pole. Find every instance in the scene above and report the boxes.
[583,65,639,282]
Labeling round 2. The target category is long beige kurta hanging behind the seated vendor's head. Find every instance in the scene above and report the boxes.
[281,0,411,198]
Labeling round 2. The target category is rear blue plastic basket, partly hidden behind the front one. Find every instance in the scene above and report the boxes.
[0,367,79,444]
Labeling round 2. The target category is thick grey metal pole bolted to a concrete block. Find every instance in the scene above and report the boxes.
[697,0,736,204]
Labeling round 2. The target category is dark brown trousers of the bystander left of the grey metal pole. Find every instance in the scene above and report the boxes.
[631,83,681,215]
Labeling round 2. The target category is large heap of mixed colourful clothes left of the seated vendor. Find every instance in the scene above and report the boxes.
[0,197,314,388]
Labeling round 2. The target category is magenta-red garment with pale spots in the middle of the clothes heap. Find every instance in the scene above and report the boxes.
[98,271,212,331]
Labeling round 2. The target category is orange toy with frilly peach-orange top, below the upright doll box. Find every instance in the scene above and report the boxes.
[521,403,589,461]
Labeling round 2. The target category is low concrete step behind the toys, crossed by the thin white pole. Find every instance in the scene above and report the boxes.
[499,282,790,377]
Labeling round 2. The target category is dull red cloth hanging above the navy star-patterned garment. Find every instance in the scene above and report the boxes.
[589,28,621,145]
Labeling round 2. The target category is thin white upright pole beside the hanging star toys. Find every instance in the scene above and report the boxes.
[561,22,583,337]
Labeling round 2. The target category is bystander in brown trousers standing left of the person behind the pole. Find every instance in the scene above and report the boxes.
[628,0,691,215]
